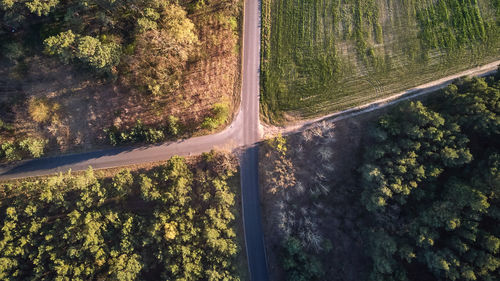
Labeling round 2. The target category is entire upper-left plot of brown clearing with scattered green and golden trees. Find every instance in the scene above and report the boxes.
[0,0,241,161]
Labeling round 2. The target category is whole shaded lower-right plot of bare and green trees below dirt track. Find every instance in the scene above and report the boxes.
[260,71,500,281]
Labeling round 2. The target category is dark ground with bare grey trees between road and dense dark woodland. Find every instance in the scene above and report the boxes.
[259,110,386,281]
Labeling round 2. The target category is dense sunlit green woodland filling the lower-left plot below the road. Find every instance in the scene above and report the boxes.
[0,152,240,281]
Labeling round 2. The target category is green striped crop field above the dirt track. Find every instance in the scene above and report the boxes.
[261,0,500,123]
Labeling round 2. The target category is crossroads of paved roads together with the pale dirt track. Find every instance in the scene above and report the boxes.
[0,0,500,281]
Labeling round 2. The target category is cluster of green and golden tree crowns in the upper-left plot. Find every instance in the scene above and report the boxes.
[0,0,198,84]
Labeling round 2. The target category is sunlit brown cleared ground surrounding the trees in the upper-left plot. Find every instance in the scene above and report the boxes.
[0,1,241,161]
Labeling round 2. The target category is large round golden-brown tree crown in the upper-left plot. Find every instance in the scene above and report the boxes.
[129,2,198,95]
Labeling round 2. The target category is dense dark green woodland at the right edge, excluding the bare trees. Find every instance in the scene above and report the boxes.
[361,75,500,281]
